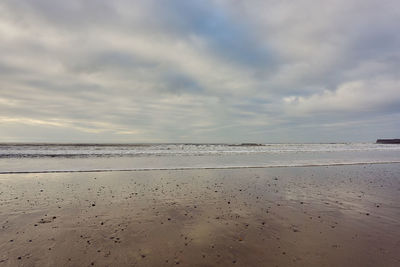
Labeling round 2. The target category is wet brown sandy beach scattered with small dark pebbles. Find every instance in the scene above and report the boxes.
[0,164,400,266]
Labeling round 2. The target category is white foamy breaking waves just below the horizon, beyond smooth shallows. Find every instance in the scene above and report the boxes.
[0,143,400,158]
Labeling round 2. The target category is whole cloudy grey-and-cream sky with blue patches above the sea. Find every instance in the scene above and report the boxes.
[0,0,400,143]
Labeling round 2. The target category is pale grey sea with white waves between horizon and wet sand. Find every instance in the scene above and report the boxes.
[0,143,400,174]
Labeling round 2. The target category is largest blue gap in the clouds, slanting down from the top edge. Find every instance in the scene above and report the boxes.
[159,0,274,68]
